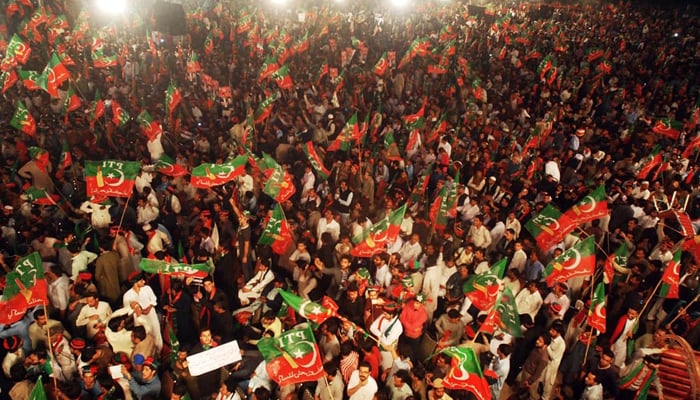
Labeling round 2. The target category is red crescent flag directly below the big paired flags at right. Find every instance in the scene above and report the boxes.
[544,236,596,287]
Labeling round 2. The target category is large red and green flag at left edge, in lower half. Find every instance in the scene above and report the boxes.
[0,252,48,325]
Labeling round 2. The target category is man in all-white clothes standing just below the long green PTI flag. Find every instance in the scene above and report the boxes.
[123,271,163,351]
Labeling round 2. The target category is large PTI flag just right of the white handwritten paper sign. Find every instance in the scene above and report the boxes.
[258,326,325,386]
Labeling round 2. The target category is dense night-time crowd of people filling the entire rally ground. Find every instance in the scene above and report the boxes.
[0,1,700,400]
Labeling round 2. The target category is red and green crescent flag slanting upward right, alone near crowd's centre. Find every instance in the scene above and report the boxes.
[350,204,406,258]
